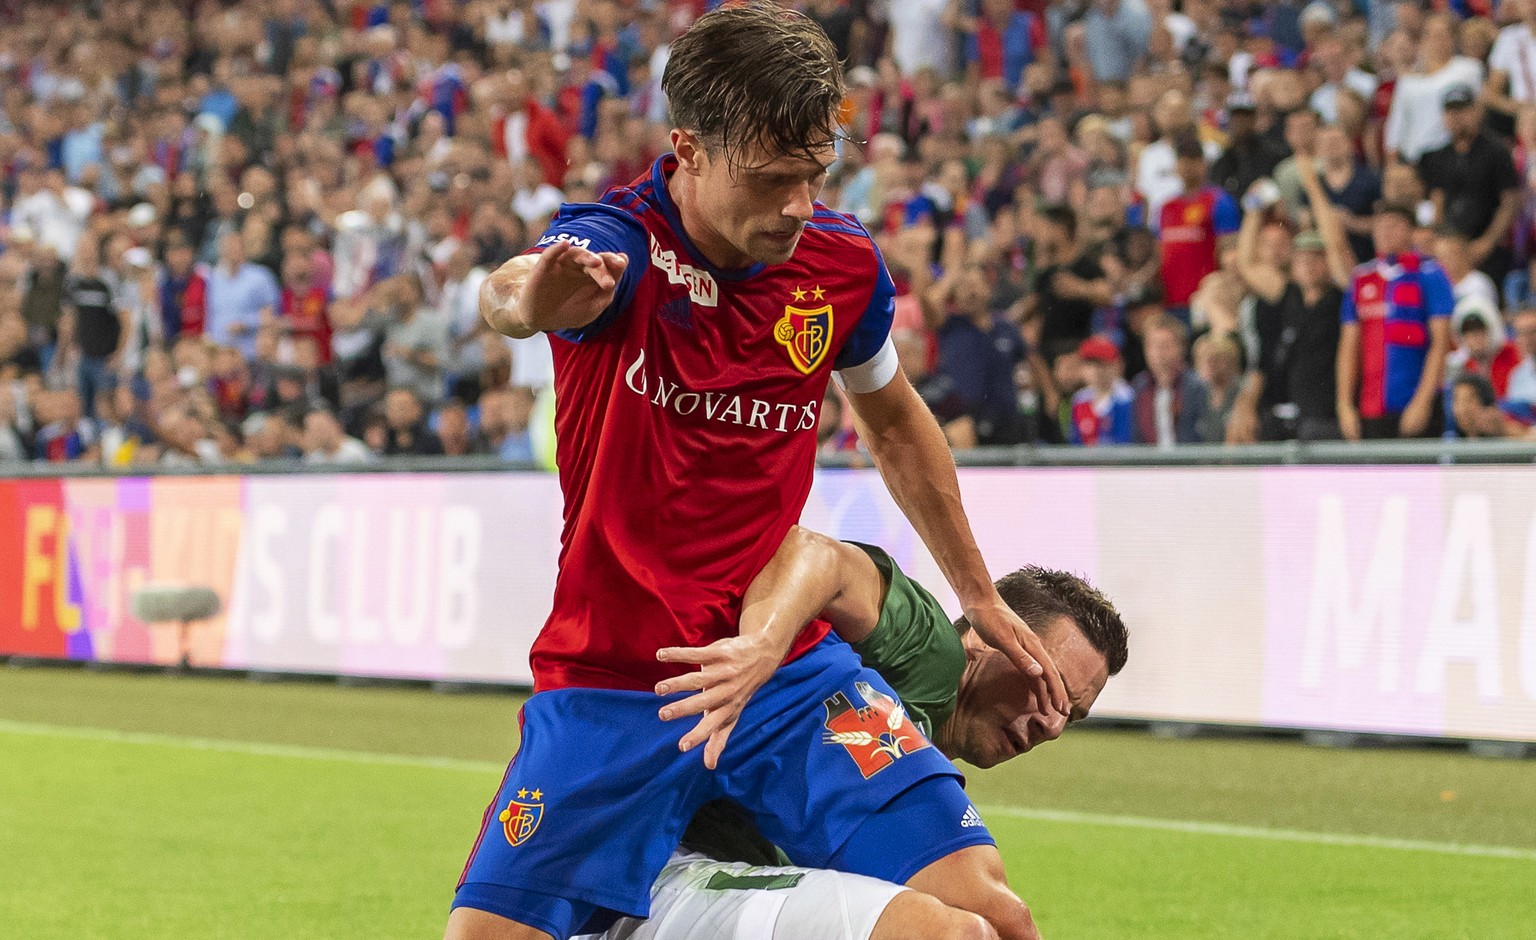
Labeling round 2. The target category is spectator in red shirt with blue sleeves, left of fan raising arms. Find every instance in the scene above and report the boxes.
[1155,134,1241,324]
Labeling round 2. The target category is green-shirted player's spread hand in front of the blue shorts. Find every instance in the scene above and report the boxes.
[656,636,788,770]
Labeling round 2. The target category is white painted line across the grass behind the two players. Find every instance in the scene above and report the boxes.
[0,719,1536,862]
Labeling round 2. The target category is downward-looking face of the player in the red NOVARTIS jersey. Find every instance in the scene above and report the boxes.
[673,131,837,267]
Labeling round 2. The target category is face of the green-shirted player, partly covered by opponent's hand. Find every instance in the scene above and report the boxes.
[942,616,1109,770]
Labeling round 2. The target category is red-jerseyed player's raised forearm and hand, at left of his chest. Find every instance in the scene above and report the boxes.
[479,241,630,339]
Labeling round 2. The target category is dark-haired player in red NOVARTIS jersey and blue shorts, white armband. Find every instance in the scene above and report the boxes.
[449,3,1069,940]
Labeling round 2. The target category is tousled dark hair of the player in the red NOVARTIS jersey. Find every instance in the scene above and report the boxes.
[662,0,845,164]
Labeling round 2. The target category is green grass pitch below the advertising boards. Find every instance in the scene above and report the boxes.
[0,667,1536,940]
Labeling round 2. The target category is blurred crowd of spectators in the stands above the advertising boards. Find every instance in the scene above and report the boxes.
[0,0,1536,467]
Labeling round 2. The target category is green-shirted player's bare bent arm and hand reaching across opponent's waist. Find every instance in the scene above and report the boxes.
[656,525,885,770]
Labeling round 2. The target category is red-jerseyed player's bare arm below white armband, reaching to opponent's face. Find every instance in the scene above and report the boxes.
[848,372,1071,714]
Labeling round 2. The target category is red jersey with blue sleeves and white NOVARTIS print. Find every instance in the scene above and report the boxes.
[531,155,895,690]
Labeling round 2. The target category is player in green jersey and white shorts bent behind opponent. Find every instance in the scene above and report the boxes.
[571,527,1127,940]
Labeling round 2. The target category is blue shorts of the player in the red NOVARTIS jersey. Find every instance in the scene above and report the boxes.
[453,636,992,940]
